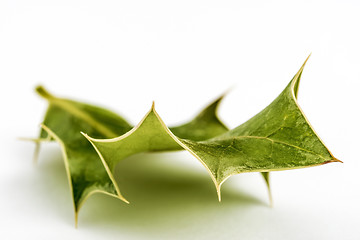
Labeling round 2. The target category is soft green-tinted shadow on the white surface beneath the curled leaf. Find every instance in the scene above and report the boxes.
[79,153,264,234]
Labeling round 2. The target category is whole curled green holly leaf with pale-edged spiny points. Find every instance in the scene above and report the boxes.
[31,56,340,225]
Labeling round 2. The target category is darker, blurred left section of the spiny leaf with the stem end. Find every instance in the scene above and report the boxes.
[36,87,132,225]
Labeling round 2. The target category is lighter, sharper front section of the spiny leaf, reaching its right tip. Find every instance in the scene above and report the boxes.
[84,56,339,200]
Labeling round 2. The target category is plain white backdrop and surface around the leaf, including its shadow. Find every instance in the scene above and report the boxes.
[0,0,360,239]
